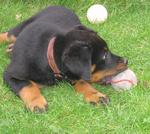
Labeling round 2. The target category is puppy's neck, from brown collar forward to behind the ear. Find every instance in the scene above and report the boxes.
[47,37,80,80]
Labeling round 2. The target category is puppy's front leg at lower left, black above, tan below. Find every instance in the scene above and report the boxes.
[4,72,48,112]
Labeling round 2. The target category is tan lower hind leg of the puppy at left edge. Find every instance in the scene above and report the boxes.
[0,32,16,43]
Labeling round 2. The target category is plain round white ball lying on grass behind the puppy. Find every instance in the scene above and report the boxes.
[87,4,108,24]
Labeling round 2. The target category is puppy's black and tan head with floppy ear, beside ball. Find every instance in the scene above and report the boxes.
[62,26,127,82]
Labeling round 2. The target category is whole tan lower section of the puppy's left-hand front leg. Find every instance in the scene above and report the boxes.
[19,82,47,112]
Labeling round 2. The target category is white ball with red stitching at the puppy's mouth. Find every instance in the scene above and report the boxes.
[111,69,137,90]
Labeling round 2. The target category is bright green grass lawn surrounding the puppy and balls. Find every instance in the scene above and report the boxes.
[0,0,150,134]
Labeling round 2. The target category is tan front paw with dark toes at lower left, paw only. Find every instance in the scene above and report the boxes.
[26,95,48,113]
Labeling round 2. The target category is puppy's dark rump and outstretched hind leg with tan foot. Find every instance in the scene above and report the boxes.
[0,6,81,42]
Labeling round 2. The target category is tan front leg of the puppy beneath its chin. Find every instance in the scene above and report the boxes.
[74,80,109,104]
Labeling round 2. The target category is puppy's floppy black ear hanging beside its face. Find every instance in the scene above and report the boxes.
[62,41,91,81]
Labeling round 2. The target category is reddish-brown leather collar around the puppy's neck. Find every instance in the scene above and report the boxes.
[47,37,62,78]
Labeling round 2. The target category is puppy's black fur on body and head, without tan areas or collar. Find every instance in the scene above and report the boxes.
[4,6,127,93]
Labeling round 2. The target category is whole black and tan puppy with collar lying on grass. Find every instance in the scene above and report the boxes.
[0,6,127,111]
